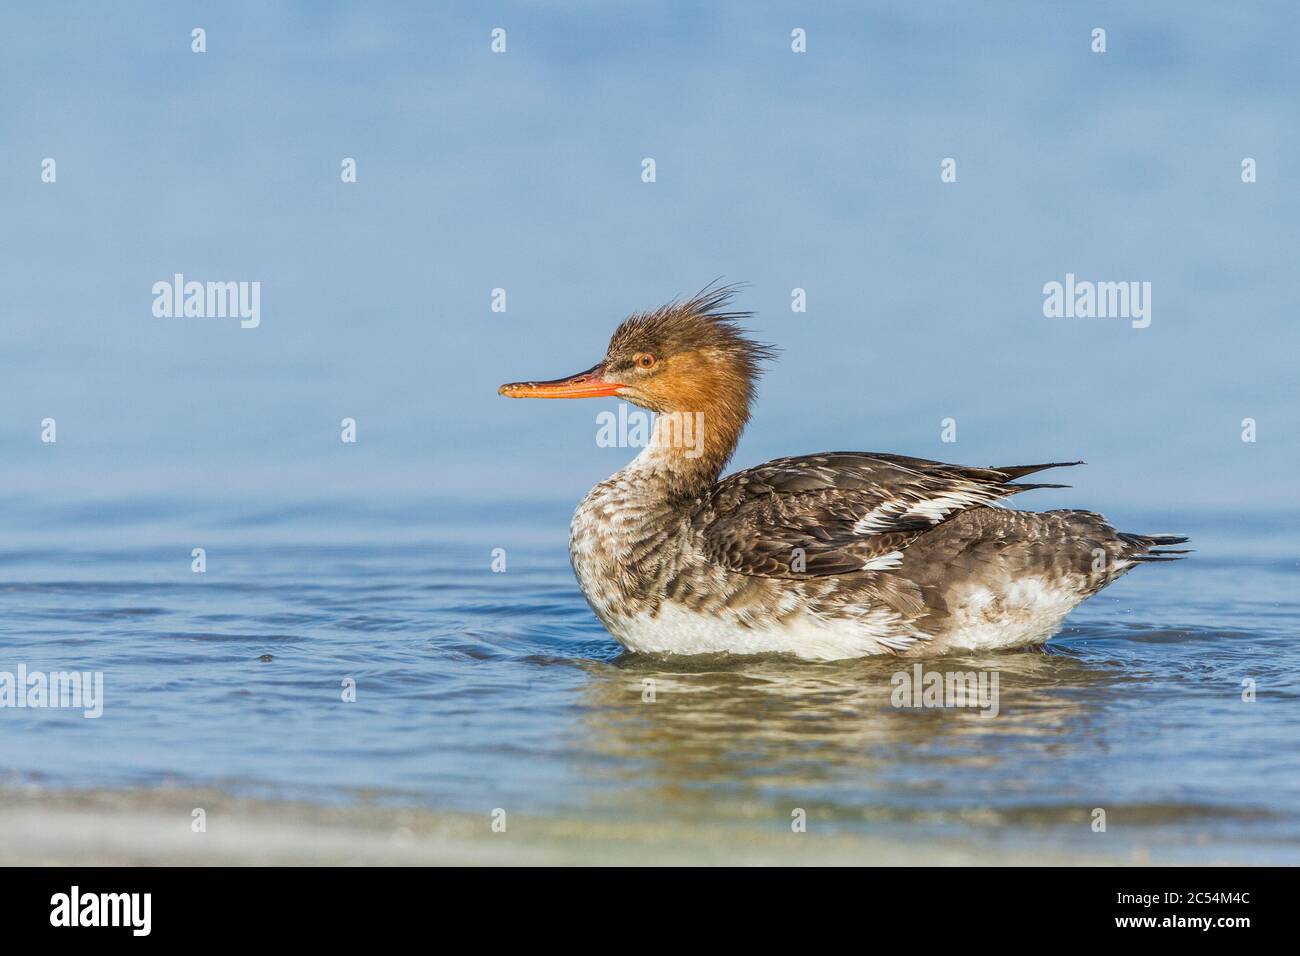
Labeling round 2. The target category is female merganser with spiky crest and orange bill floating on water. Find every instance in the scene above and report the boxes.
[501,287,1187,661]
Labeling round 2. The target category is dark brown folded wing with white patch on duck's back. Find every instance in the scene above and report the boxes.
[696,451,1076,579]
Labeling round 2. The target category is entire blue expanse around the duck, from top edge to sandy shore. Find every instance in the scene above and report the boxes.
[0,0,1300,861]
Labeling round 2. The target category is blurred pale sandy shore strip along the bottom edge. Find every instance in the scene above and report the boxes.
[0,788,1247,866]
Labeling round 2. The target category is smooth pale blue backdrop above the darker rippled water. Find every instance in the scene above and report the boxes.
[0,3,1300,516]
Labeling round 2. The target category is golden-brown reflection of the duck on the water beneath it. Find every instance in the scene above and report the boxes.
[574,652,1134,821]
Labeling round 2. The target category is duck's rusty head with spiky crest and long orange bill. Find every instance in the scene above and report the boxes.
[499,286,775,418]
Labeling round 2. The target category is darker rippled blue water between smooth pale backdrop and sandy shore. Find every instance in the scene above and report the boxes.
[0,496,1300,861]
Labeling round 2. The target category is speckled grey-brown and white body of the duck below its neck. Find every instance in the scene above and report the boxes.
[569,449,1174,659]
